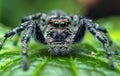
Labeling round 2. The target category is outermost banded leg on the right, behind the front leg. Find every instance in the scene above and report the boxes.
[96,25,119,55]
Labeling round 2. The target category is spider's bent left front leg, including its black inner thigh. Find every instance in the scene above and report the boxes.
[22,21,46,70]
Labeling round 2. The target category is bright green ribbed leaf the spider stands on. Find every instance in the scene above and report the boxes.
[0,21,120,76]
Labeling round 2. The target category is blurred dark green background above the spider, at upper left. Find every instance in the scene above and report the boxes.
[0,0,79,26]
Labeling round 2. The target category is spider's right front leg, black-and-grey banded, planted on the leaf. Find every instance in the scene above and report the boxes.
[84,19,115,70]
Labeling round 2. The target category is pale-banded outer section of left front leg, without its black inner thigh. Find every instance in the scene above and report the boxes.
[22,22,36,70]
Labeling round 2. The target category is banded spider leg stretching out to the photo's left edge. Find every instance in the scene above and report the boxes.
[0,22,29,50]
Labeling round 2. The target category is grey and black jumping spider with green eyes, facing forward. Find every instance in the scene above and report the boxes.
[0,10,118,70]
